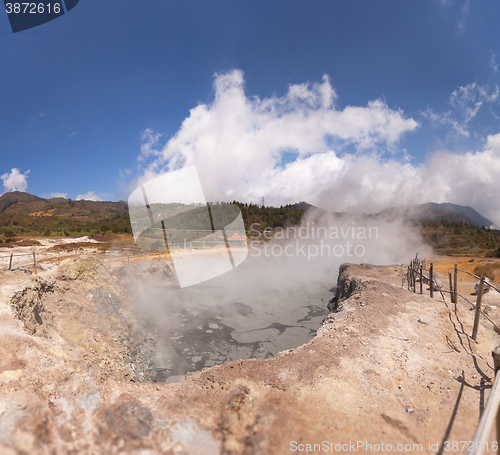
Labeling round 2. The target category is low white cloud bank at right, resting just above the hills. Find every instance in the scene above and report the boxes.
[261,134,500,225]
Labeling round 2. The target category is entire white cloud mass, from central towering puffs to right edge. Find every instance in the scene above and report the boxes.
[134,71,500,225]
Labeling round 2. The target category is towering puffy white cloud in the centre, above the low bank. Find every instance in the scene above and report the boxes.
[135,70,418,200]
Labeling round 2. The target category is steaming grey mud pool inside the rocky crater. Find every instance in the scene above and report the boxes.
[139,280,335,383]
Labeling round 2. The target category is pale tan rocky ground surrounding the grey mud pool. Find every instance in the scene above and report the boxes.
[0,258,500,455]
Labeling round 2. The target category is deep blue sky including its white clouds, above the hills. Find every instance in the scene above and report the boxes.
[0,0,500,224]
